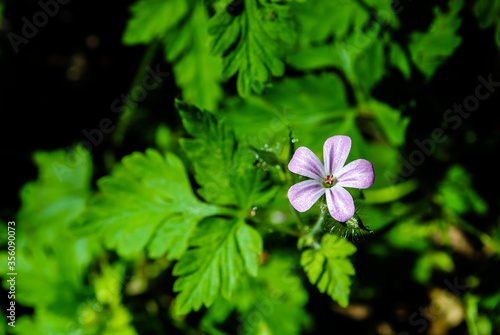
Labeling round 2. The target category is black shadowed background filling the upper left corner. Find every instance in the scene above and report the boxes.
[0,0,176,219]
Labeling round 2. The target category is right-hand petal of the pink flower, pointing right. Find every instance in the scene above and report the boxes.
[337,159,375,188]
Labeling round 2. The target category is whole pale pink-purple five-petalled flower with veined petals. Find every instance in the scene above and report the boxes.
[288,135,375,222]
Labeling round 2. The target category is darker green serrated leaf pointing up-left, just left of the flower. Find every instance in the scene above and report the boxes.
[176,101,275,209]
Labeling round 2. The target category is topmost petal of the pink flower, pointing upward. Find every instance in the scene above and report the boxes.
[323,135,351,176]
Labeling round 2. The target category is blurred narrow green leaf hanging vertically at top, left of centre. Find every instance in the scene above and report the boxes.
[165,1,223,110]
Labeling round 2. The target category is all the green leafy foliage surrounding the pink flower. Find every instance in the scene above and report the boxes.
[0,0,500,335]
